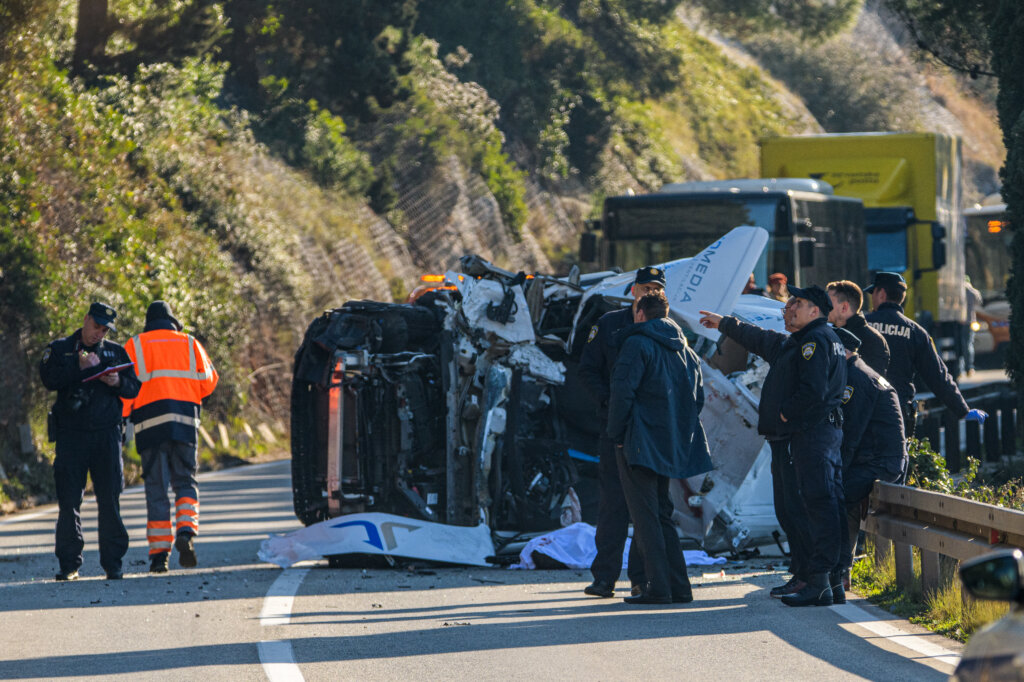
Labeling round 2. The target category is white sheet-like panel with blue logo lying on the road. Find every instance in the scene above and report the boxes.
[258,513,495,568]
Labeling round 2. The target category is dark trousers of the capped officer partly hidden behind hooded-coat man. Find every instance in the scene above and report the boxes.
[590,437,644,585]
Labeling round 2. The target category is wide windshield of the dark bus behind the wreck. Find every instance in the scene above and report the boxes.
[602,195,793,287]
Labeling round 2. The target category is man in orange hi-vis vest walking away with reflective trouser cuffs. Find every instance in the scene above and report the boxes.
[124,301,217,573]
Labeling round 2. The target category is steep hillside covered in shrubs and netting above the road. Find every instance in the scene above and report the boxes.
[0,0,1002,501]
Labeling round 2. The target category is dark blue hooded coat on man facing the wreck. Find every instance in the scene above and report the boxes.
[607,317,713,478]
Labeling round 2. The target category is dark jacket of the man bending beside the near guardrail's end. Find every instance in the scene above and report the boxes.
[841,353,906,475]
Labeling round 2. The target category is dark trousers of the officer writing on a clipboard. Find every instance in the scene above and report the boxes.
[53,427,128,573]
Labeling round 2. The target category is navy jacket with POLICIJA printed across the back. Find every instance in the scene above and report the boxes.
[867,301,969,419]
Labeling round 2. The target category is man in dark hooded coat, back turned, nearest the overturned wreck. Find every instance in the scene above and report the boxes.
[608,292,712,604]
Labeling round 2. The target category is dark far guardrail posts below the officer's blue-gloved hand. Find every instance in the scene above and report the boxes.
[916,381,1018,472]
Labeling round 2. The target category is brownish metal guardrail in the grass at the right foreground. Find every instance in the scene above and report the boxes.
[863,481,1024,592]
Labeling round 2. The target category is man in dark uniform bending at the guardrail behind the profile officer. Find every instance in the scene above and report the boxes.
[833,328,907,590]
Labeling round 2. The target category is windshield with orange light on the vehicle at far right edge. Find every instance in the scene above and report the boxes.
[964,206,1013,303]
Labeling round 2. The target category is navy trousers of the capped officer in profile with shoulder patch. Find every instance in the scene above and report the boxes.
[790,421,846,576]
